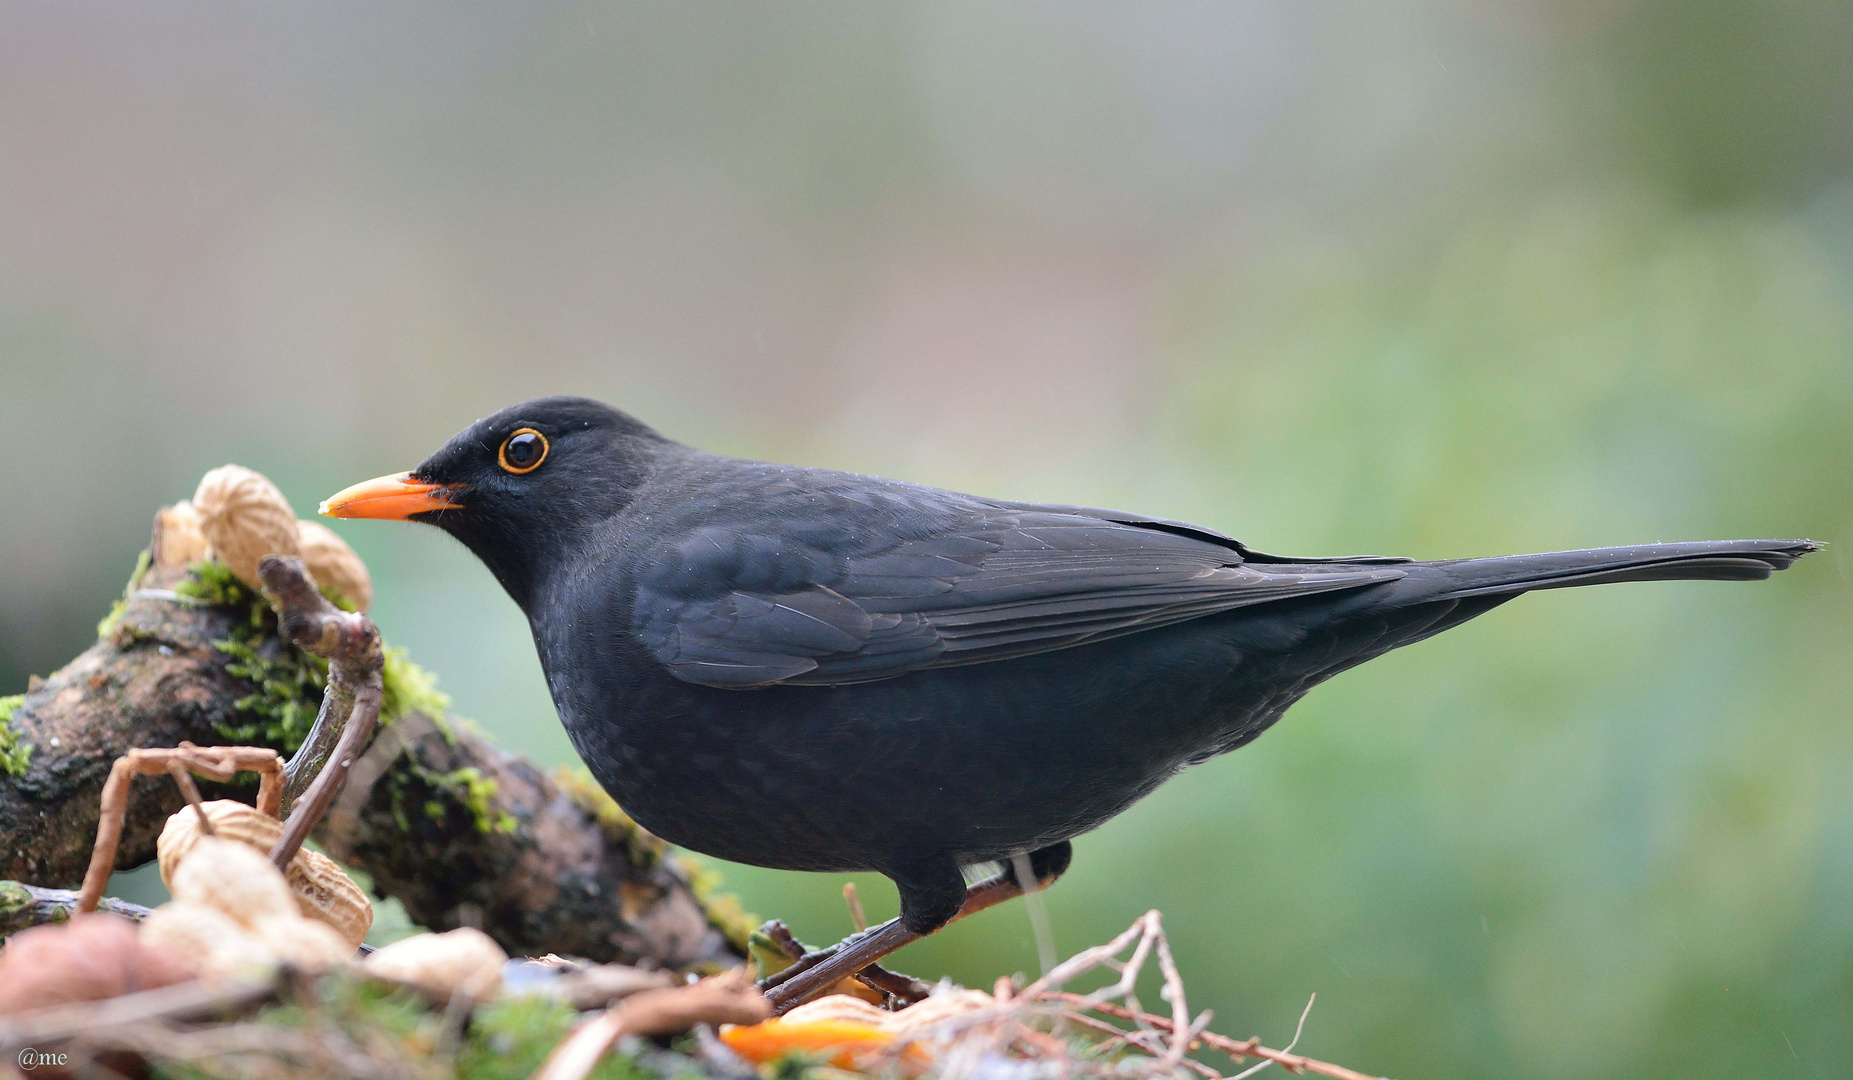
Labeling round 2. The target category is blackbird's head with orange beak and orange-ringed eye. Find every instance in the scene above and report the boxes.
[321,396,671,608]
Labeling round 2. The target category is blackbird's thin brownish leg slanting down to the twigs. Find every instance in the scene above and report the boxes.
[760,841,1073,1013]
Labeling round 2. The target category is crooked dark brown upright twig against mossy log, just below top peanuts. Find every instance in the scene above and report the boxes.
[258,556,385,869]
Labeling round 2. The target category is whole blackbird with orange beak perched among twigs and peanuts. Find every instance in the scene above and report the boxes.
[322,396,1818,1006]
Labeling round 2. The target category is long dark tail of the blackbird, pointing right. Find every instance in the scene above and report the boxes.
[1392,541,1821,602]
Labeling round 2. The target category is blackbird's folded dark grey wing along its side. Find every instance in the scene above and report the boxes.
[632,478,1403,687]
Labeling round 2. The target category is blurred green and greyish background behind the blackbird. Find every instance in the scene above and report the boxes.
[0,0,1853,1078]
